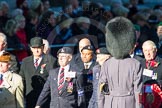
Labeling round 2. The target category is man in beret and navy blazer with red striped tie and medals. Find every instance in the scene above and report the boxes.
[35,47,85,108]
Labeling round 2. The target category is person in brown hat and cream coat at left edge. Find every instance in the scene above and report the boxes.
[0,52,24,108]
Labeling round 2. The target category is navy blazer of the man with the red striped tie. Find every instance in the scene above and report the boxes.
[37,66,85,108]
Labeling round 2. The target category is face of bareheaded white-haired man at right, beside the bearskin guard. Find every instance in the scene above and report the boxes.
[143,45,157,61]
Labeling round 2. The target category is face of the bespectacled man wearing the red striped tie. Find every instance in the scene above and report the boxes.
[57,53,72,67]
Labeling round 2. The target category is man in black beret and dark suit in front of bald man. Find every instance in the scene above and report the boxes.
[75,45,96,107]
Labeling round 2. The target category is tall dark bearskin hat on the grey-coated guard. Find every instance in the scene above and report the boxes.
[106,17,136,59]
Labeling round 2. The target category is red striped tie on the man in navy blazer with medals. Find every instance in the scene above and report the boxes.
[58,68,64,94]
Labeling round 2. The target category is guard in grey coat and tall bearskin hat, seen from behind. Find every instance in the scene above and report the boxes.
[98,17,143,108]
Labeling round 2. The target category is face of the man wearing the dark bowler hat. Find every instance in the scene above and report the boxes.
[30,46,44,57]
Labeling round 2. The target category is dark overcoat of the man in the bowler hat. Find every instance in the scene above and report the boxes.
[19,55,56,108]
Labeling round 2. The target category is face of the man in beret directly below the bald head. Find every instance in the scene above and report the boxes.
[81,49,93,63]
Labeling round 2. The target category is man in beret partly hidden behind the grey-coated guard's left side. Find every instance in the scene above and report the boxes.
[88,47,111,108]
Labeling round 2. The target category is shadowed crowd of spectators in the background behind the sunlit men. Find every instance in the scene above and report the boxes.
[0,0,162,62]
